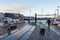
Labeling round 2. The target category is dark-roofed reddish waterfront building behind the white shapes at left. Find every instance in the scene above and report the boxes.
[4,13,24,23]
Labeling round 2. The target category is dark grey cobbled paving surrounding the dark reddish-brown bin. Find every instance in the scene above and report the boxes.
[28,24,60,40]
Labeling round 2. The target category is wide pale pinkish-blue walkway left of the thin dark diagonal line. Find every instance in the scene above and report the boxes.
[2,24,33,40]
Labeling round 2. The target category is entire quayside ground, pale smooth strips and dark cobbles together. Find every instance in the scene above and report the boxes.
[1,23,60,40]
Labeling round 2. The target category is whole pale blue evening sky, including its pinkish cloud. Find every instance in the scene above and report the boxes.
[0,0,60,16]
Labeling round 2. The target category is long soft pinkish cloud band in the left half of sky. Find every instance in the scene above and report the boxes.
[0,4,31,11]
